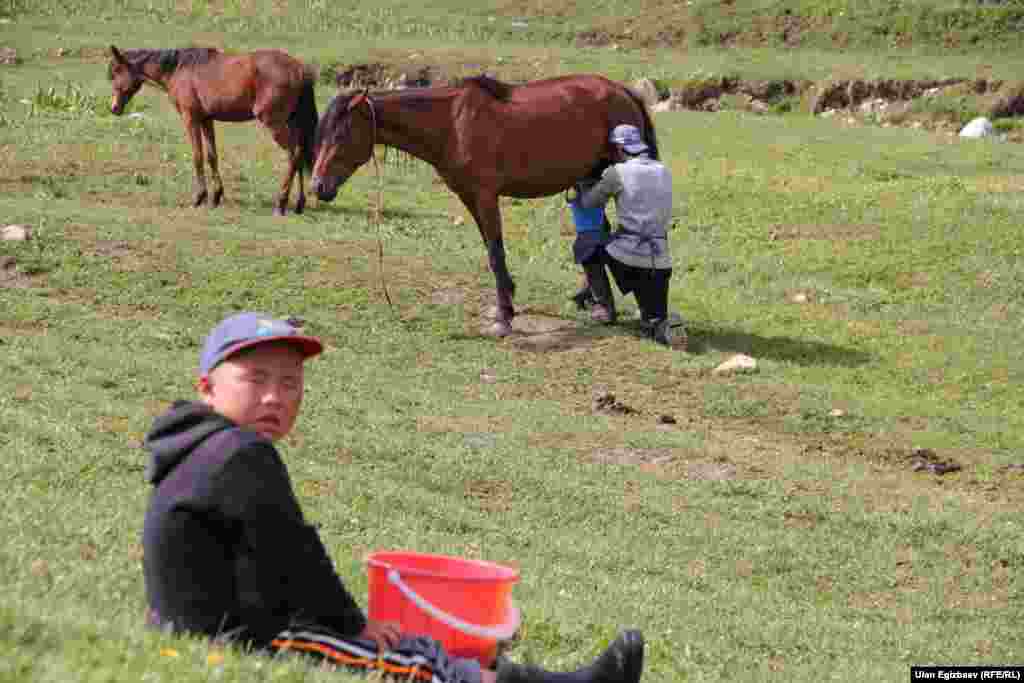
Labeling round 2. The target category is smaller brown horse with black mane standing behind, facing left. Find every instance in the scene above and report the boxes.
[110,45,317,215]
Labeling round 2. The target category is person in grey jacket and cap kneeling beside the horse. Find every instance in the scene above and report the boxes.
[577,124,685,346]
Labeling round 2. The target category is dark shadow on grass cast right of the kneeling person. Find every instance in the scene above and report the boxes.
[687,325,872,368]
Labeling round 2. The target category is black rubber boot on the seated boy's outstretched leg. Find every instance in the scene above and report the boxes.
[498,631,643,683]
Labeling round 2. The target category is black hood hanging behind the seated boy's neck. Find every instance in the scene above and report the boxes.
[143,400,236,485]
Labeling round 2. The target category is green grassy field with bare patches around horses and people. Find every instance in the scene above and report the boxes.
[0,0,1024,682]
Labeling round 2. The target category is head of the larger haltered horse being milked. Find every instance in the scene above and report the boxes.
[310,91,377,202]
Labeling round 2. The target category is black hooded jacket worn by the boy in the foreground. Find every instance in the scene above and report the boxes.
[142,401,366,646]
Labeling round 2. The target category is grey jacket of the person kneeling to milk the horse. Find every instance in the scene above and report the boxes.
[580,154,672,268]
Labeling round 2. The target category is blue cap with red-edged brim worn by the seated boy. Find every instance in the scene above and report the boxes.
[199,312,324,376]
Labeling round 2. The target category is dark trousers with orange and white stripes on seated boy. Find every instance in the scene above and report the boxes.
[270,626,482,683]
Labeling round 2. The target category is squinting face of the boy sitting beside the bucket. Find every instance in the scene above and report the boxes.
[199,342,305,441]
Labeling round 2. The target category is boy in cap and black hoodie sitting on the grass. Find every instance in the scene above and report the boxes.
[142,312,643,683]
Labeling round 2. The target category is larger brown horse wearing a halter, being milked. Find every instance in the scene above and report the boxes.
[310,76,657,337]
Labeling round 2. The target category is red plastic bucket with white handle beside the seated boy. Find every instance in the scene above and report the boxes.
[367,551,520,667]
